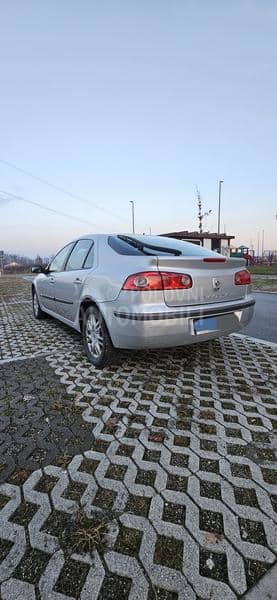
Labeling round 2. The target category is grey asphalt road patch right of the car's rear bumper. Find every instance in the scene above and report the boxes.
[240,292,277,343]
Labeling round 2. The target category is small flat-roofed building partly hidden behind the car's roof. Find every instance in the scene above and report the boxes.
[160,231,235,256]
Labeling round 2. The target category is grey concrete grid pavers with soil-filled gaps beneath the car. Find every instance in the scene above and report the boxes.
[0,278,277,600]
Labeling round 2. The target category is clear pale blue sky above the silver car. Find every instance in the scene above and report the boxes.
[0,0,277,256]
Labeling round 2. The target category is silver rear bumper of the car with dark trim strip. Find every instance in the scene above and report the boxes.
[106,297,255,348]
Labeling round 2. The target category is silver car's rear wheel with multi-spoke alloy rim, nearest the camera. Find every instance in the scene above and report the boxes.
[82,306,114,369]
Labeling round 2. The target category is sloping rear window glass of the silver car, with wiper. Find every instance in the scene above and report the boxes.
[108,235,222,257]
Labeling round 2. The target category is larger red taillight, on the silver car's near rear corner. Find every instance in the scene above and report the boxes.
[122,271,192,292]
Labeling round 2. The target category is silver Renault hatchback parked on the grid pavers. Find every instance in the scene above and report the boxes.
[32,234,255,368]
